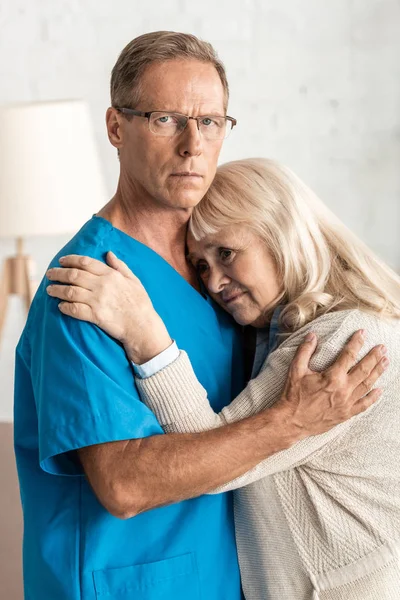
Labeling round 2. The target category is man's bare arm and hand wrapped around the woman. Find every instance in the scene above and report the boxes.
[78,335,382,518]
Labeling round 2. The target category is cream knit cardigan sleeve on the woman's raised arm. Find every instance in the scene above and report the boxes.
[136,311,379,493]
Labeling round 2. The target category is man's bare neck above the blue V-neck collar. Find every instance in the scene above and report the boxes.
[97,190,199,290]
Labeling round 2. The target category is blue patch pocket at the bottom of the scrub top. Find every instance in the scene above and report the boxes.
[93,553,200,600]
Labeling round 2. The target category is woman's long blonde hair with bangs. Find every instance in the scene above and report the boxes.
[189,158,400,332]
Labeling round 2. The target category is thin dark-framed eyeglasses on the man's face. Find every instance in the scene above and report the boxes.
[115,107,237,140]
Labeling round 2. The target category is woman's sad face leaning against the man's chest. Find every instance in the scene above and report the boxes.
[187,225,282,327]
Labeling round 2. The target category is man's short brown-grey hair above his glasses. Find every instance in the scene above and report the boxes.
[110,31,229,110]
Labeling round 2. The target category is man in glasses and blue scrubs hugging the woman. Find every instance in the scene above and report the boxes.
[15,32,382,600]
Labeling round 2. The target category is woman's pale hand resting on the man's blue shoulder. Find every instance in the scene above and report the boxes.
[46,252,171,364]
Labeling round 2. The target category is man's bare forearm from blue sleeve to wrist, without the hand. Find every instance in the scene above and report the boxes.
[78,409,294,519]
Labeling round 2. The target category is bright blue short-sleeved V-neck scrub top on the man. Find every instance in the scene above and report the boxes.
[14,217,243,600]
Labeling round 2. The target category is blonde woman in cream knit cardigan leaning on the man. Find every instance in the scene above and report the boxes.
[45,159,400,600]
